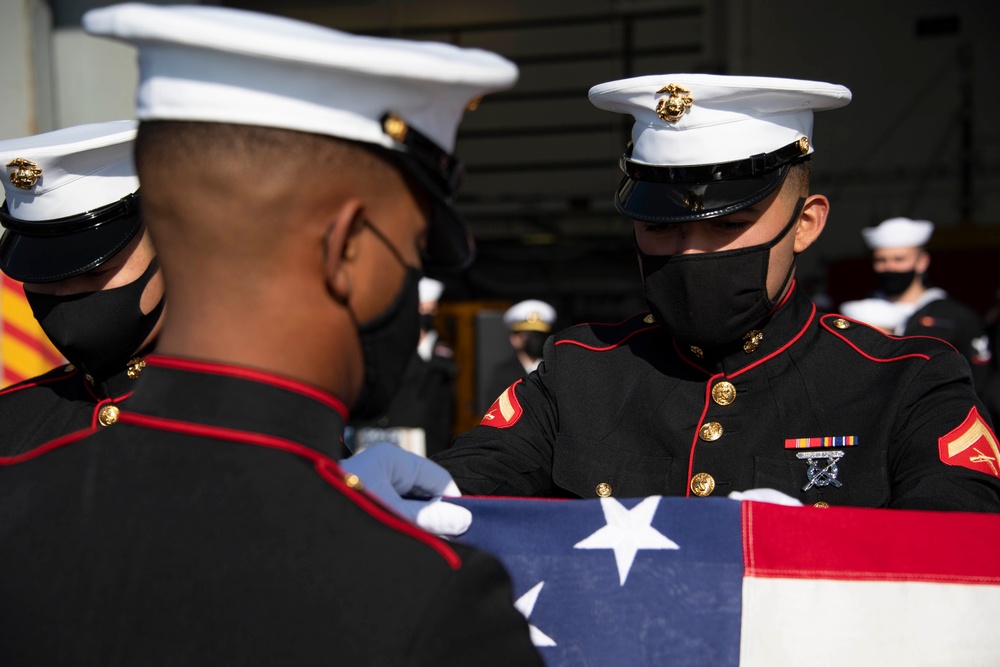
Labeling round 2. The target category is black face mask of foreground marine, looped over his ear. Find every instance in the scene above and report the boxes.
[351,221,422,419]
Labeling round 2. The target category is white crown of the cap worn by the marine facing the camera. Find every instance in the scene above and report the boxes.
[589,74,851,167]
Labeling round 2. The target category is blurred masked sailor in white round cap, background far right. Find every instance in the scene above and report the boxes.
[861,217,993,390]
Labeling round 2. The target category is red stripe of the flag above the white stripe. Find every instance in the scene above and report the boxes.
[743,502,1000,584]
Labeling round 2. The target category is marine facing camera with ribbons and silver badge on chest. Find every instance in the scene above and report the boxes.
[437,74,1000,511]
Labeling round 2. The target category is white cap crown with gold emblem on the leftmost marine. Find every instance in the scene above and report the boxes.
[0,120,139,222]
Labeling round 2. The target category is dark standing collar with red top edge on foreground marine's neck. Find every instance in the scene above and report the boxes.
[122,355,348,458]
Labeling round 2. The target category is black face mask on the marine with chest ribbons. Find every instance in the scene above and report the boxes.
[636,198,805,348]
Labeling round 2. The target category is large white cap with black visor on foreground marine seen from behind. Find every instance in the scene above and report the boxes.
[83,3,517,268]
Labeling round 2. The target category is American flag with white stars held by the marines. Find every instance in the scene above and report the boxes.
[456,497,1000,667]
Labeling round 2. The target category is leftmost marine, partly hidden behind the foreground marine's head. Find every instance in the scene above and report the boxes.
[0,121,164,456]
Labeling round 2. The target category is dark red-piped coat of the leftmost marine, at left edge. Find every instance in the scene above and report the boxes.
[0,357,145,456]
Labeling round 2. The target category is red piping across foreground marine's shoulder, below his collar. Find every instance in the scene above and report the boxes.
[118,412,462,570]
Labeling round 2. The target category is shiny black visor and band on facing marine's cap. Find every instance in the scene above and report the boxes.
[615,142,805,223]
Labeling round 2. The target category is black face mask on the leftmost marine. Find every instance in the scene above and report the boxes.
[24,257,164,380]
